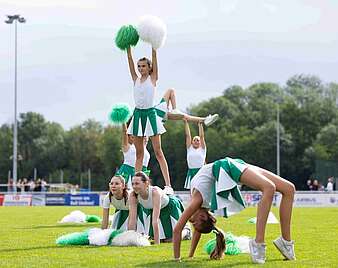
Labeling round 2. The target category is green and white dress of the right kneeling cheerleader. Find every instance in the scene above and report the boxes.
[137,186,184,239]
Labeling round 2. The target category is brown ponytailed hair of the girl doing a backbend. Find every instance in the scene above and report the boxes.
[194,211,225,260]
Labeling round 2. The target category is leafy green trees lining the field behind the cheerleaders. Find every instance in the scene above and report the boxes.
[0,75,338,190]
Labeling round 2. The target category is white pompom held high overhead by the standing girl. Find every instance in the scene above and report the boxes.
[137,15,167,49]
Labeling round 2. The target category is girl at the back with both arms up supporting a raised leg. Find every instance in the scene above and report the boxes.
[184,120,207,189]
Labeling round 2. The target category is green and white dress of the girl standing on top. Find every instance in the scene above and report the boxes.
[128,76,167,137]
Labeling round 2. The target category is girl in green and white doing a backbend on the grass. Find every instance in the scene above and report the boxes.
[173,157,296,263]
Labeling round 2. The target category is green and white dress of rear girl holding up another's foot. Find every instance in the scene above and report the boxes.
[184,145,207,189]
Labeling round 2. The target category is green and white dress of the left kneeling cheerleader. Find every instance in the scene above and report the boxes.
[102,192,148,234]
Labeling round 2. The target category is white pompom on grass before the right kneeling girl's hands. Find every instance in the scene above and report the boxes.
[111,231,150,247]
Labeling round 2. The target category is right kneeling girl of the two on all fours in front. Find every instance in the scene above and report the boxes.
[128,172,190,244]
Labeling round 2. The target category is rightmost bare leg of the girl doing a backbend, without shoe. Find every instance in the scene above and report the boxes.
[253,166,296,241]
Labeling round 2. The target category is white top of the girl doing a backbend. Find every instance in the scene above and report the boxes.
[190,163,216,208]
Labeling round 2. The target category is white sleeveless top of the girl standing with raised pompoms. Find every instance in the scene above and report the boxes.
[134,75,156,109]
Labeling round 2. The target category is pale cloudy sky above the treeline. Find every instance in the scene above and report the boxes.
[0,0,338,129]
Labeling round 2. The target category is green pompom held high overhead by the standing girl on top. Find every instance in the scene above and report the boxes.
[115,25,140,50]
